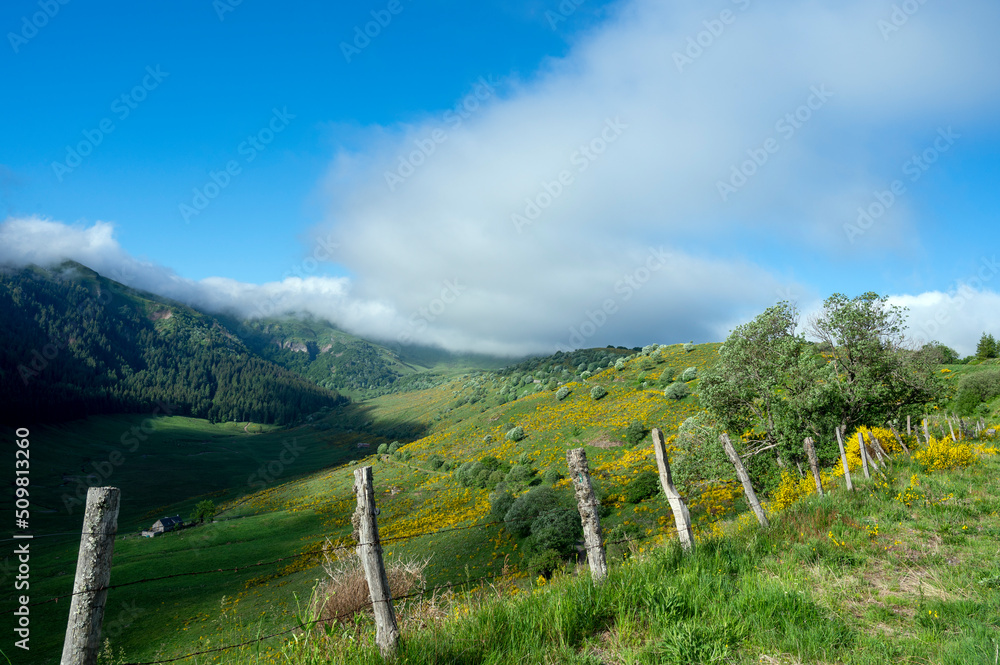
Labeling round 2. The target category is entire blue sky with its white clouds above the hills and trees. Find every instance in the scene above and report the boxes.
[0,0,1000,353]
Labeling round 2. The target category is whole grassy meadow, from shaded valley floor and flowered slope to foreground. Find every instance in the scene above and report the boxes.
[9,345,1000,663]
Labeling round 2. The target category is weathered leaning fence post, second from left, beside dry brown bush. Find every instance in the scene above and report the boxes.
[351,466,399,658]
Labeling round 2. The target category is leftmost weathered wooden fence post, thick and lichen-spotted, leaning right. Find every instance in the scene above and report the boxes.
[59,487,121,665]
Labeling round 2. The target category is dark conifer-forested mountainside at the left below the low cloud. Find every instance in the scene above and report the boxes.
[0,263,345,424]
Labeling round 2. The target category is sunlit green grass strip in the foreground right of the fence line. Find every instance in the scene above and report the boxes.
[268,457,1000,665]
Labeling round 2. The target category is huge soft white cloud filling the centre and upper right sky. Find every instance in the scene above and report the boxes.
[318,0,1000,346]
